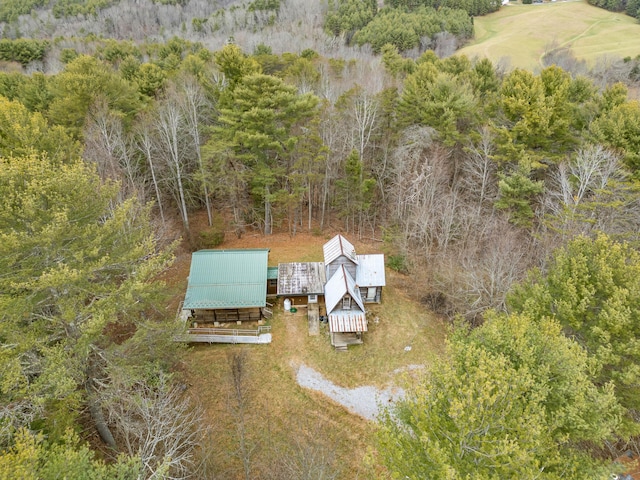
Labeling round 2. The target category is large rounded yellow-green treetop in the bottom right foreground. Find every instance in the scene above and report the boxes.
[379,315,621,480]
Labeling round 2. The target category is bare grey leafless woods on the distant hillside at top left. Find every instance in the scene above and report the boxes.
[0,0,330,64]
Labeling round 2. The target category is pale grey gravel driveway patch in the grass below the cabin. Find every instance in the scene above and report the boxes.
[296,364,404,420]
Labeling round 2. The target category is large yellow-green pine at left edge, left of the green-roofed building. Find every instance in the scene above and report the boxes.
[0,152,182,472]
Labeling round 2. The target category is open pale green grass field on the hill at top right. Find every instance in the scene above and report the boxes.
[458,0,640,70]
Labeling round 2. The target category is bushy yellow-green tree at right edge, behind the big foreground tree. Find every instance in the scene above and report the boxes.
[509,234,640,432]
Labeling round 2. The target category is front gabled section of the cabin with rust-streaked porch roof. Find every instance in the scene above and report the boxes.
[324,265,367,348]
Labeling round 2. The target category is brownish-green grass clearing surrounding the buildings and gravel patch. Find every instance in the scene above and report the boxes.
[164,214,446,479]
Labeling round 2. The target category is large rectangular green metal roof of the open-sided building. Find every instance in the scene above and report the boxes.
[183,248,269,309]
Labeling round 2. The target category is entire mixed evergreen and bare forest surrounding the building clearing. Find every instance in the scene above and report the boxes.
[0,0,640,479]
